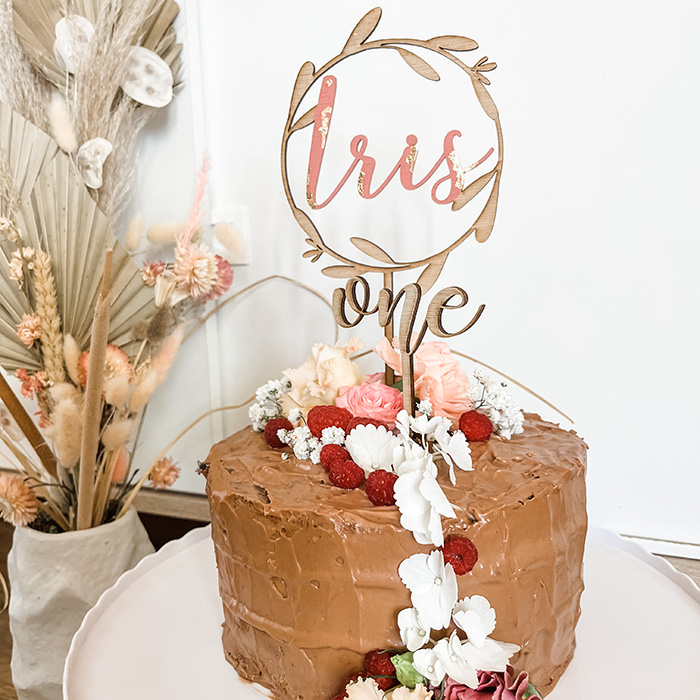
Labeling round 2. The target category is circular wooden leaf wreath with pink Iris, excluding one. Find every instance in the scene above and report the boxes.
[281,8,503,291]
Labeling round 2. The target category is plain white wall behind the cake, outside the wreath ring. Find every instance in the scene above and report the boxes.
[130,0,700,543]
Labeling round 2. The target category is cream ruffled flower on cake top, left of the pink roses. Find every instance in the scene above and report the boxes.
[281,338,364,415]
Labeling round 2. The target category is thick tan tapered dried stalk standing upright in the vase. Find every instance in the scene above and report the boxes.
[76,248,112,530]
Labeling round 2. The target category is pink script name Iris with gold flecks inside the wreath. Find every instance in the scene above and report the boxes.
[306,75,493,209]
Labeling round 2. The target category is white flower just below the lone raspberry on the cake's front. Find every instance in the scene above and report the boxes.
[399,549,457,632]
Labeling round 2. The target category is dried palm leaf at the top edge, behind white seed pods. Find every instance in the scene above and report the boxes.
[13,0,182,90]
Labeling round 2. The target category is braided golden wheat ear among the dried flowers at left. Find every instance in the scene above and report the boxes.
[34,250,66,384]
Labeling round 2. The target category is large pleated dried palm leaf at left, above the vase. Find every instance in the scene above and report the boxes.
[0,103,156,369]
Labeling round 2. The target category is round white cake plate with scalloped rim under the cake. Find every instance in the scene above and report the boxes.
[63,527,700,700]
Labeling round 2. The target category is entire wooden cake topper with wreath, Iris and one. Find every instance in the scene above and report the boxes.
[281,8,503,414]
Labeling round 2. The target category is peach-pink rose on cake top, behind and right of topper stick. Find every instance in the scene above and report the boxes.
[374,338,473,427]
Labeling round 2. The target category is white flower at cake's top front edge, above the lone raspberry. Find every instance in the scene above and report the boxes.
[394,456,455,547]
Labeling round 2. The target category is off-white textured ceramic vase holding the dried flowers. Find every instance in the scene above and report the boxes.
[7,509,153,700]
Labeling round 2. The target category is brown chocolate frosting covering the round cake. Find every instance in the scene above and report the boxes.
[207,415,587,700]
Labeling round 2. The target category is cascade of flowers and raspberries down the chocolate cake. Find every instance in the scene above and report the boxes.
[249,338,541,700]
